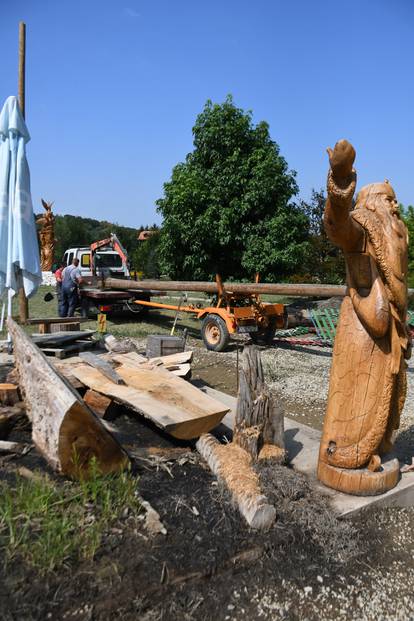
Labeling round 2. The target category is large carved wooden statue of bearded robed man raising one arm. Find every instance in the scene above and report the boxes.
[318,140,411,495]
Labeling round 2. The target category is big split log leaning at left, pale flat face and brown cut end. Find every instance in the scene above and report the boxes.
[8,319,129,477]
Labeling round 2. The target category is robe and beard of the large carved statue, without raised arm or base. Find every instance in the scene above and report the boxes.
[319,191,410,468]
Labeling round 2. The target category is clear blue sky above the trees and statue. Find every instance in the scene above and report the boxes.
[0,0,414,226]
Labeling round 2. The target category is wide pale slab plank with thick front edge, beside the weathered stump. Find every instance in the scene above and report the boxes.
[71,364,229,440]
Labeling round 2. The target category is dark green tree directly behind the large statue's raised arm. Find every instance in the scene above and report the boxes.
[299,189,345,284]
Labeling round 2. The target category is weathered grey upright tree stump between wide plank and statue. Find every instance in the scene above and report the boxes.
[233,345,286,463]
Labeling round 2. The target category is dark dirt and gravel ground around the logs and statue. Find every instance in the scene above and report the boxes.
[0,342,414,621]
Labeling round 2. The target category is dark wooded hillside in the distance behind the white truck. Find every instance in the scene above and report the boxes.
[35,214,158,261]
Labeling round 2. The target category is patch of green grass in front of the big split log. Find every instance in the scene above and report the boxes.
[0,462,140,573]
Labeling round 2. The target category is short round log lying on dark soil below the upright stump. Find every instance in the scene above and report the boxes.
[196,433,276,530]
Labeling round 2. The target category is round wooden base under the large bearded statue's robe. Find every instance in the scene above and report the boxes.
[318,456,400,496]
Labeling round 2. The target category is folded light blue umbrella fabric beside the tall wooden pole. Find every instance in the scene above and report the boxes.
[0,97,42,297]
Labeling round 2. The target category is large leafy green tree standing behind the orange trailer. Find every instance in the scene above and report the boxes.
[157,96,308,281]
